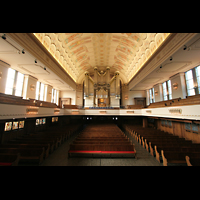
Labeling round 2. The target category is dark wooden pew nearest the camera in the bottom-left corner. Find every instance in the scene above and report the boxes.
[0,153,20,166]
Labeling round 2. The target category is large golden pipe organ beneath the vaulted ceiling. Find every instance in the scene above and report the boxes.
[84,67,121,108]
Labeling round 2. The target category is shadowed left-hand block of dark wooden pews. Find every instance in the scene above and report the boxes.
[0,125,82,166]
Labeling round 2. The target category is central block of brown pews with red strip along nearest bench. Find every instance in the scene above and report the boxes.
[68,124,136,157]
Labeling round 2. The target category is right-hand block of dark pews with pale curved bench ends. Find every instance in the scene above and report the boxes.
[123,124,200,166]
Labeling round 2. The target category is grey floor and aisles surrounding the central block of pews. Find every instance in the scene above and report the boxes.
[33,127,163,166]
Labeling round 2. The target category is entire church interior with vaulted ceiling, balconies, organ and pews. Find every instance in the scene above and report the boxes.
[0,33,200,166]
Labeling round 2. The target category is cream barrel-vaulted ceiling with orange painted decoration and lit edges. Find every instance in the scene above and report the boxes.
[34,33,170,83]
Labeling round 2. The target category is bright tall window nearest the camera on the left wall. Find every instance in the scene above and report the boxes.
[5,68,24,96]
